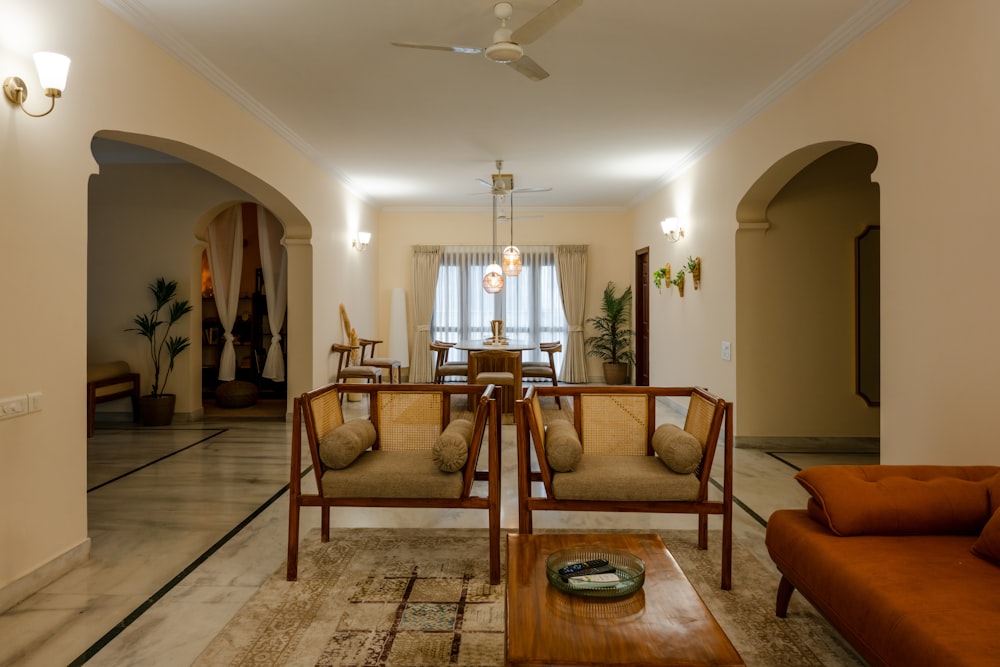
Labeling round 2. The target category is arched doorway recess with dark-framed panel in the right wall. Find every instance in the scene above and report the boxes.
[736,141,879,446]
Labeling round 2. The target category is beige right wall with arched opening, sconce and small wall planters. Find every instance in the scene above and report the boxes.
[635,0,1000,464]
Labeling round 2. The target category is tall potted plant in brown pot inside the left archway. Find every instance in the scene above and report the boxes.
[126,278,191,426]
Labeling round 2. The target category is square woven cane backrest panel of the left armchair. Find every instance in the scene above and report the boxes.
[378,391,443,452]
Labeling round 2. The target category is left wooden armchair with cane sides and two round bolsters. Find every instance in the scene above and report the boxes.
[286,384,500,584]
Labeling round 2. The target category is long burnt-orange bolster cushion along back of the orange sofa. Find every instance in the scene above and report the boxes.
[795,465,1000,536]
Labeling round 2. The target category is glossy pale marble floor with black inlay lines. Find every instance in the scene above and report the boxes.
[0,396,878,667]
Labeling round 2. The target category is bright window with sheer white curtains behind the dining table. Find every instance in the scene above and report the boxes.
[431,246,567,361]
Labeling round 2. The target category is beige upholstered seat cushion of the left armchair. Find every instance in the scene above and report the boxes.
[323,449,466,498]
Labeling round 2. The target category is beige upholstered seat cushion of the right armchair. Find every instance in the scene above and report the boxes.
[552,454,701,501]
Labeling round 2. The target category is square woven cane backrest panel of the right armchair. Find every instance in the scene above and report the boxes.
[580,394,649,456]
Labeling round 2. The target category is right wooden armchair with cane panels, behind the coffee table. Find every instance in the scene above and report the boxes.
[516,386,733,590]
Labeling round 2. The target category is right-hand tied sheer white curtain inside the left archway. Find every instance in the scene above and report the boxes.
[257,206,288,382]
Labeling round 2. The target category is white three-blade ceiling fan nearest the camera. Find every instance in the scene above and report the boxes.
[392,0,583,81]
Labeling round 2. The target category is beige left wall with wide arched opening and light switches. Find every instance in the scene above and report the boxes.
[0,0,375,607]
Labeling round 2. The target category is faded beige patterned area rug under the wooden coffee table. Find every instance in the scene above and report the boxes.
[195,529,864,667]
